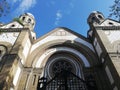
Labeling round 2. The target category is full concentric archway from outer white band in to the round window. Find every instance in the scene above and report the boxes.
[22,30,99,90]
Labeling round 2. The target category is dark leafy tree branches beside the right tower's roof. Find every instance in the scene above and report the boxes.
[109,0,120,22]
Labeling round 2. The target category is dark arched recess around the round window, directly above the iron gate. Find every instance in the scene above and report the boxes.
[43,51,84,79]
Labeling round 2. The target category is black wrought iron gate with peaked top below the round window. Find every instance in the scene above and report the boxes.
[37,70,87,90]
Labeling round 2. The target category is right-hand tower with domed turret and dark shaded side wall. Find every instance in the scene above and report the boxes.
[88,12,120,90]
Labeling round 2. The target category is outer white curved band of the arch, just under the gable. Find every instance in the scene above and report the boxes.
[30,31,95,53]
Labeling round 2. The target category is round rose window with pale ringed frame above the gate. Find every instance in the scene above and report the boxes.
[44,56,80,78]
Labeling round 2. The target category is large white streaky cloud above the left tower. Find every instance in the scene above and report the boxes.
[14,0,36,14]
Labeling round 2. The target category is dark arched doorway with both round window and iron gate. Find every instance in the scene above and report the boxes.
[37,49,97,90]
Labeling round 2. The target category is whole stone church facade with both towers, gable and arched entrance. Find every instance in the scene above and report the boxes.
[0,11,120,90]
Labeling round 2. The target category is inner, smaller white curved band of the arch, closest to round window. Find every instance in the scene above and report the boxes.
[32,47,90,68]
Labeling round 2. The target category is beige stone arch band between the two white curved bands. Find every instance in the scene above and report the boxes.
[26,40,99,67]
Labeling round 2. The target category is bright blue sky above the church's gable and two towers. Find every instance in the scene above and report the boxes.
[0,0,114,37]
